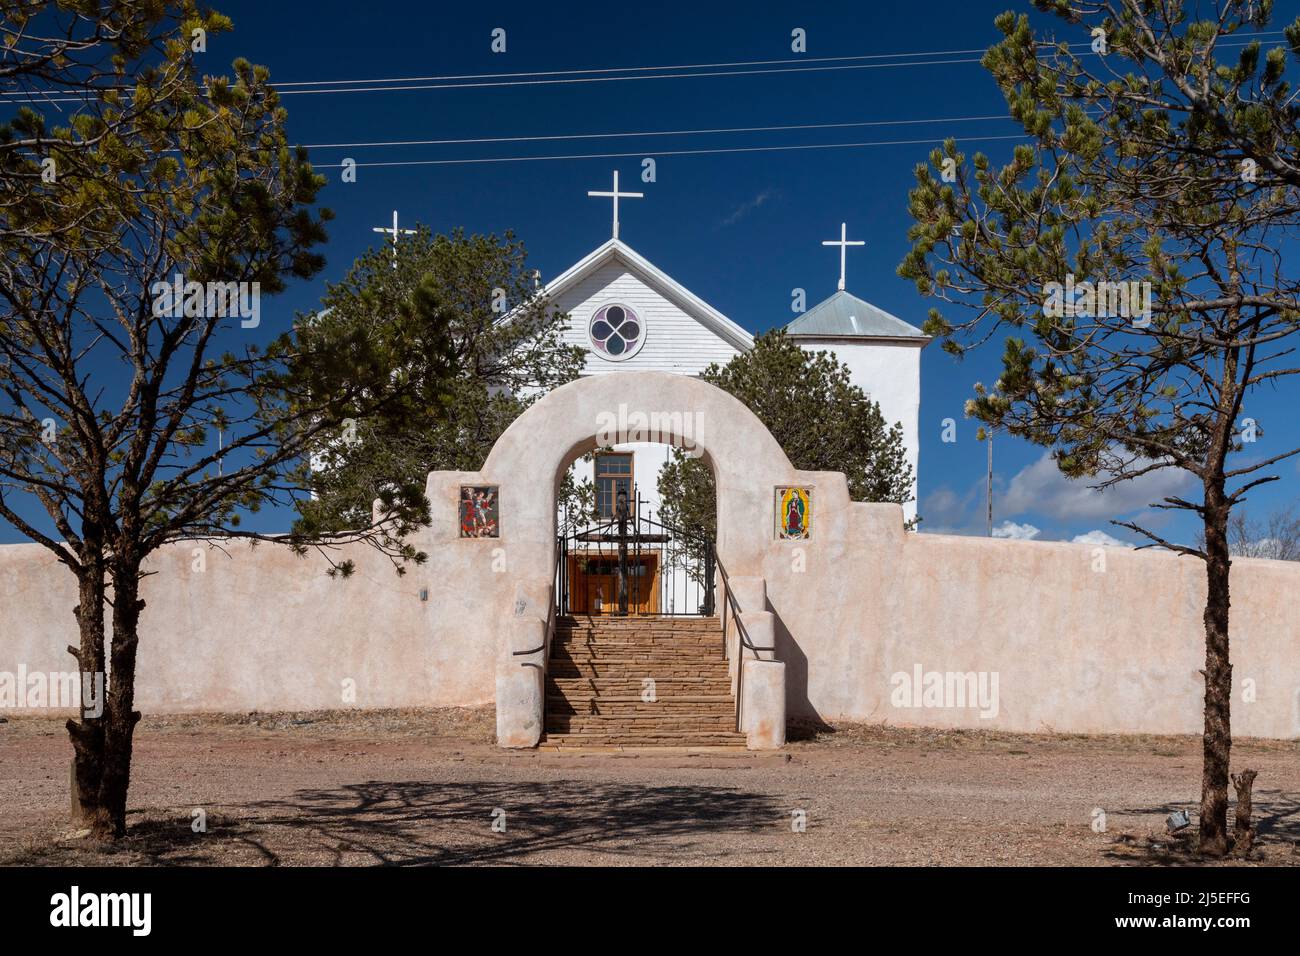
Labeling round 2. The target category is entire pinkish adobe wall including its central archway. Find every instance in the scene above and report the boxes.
[0,372,1300,737]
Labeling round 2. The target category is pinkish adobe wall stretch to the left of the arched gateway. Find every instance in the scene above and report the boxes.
[0,530,493,713]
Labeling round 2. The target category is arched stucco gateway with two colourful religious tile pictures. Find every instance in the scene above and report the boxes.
[428,372,848,749]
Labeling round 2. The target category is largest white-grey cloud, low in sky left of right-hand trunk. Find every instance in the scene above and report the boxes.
[997,451,1192,522]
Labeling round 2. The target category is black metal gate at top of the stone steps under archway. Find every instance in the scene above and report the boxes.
[555,486,716,618]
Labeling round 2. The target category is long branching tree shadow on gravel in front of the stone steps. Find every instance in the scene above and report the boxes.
[12,780,790,866]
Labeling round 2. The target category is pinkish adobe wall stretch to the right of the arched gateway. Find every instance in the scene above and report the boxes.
[764,503,1300,737]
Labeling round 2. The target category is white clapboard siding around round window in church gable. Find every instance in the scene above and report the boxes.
[555,260,738,375]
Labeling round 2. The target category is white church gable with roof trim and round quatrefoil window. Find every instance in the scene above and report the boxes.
[546,239,753,375]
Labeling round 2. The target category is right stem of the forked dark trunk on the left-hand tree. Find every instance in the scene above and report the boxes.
[91,561,144,838]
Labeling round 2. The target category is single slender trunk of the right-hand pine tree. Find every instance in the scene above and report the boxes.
[1200,504,1232,856]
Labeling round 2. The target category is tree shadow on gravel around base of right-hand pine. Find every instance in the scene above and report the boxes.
[1105,790,1300,865]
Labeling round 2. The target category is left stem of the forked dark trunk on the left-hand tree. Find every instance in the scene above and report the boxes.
[66,555,107,830]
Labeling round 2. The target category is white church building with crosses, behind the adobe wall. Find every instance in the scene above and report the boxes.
[545,172,930,535]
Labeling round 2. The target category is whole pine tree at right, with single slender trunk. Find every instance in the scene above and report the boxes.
[900,0,1300,855]
